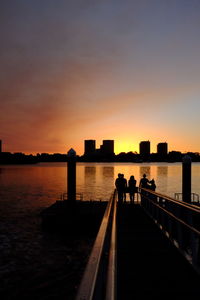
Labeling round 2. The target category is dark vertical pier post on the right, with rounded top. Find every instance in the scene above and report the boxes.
[182,155,192,203]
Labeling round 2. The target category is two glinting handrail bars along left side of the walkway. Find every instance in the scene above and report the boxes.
[76,191,116,300]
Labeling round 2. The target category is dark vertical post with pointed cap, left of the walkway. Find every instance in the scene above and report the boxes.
[67,148,76,201]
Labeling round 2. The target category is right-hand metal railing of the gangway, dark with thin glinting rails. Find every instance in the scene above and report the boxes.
[140,189,200,273]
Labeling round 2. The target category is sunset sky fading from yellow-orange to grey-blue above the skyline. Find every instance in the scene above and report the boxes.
[0,0,200,155]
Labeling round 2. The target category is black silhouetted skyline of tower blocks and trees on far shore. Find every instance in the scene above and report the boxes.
[0,139,200,165]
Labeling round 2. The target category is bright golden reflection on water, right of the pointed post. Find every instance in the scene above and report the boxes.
[77,163,200,200]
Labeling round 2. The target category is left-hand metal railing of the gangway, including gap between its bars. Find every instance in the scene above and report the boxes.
[76,191,117,300]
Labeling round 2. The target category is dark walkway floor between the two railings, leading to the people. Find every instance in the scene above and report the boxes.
[117,203,200,300]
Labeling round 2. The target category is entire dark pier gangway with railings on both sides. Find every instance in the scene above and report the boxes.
[76,189,200,300]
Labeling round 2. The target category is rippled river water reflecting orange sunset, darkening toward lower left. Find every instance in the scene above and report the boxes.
[0,163,200,299]
